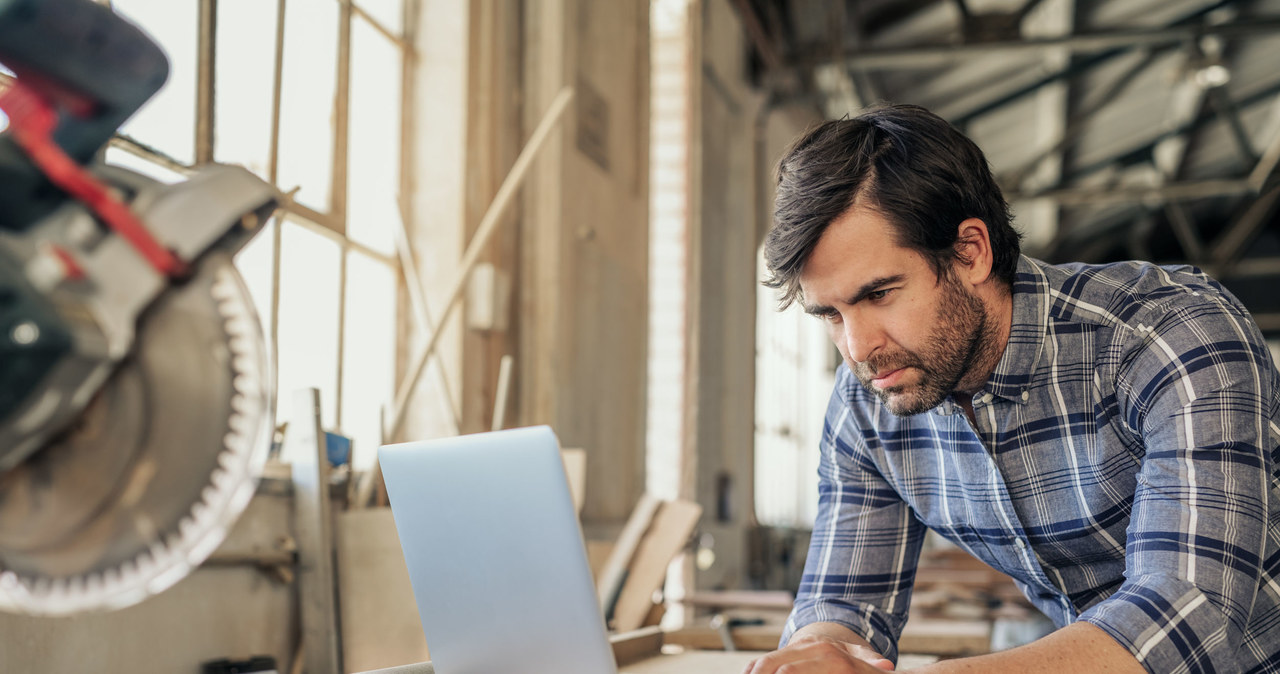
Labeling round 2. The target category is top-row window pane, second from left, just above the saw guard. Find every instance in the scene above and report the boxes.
[214,0,276,178]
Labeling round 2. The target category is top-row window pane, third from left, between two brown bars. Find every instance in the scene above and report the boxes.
[276,0,338,212]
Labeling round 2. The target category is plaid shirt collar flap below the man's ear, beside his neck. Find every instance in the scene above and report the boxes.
[984,256,1050,404]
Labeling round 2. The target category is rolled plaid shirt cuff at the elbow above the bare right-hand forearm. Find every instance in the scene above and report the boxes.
[1080,578,1242,673]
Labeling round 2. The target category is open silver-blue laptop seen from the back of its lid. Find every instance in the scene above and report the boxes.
[378,426,617,674]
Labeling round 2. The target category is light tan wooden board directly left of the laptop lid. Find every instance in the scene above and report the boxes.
[338,508,430,671]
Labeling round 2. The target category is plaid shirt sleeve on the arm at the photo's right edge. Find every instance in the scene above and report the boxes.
[1080,299,1276,673]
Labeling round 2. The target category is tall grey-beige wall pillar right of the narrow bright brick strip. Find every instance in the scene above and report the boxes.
[685,0,762,588]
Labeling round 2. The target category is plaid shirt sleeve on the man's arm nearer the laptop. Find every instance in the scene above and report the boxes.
[782,367,924,661]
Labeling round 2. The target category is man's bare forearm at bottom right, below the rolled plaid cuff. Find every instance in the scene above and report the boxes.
[913,623,1147,674]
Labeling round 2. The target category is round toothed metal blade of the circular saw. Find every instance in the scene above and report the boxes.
[0,253,273,615]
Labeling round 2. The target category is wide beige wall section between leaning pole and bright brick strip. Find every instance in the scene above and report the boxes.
[513,0,649,523]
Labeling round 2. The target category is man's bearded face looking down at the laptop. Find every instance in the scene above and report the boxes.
[800,206,996,417]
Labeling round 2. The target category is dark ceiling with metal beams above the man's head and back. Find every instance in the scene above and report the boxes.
[731,0,1280,336]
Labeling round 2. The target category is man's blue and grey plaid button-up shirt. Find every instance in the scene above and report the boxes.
[782,257,1280,673]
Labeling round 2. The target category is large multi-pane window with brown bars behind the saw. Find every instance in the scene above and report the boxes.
[106,0,413,469]
